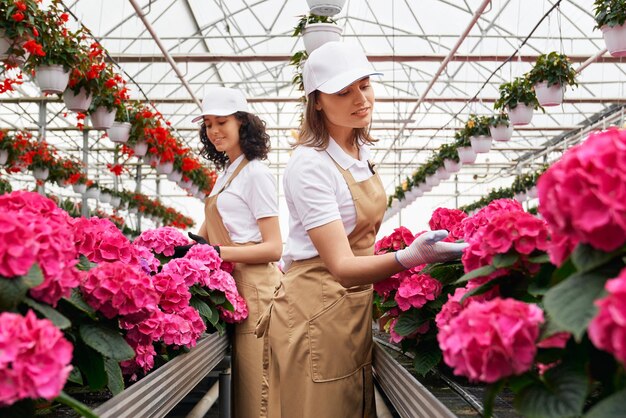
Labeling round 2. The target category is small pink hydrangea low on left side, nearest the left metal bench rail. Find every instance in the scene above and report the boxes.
[162,306,206,348]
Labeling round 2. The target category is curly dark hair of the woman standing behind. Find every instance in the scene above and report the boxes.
[199,112,270,170]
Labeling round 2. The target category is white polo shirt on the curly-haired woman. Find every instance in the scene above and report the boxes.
[209,154,278,244]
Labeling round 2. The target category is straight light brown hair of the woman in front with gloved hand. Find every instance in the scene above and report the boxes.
[291,90,378,149]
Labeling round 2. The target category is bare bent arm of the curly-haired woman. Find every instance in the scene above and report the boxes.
[217,216,283,264]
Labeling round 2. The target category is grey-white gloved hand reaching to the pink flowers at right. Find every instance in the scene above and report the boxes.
[395,229,469,269]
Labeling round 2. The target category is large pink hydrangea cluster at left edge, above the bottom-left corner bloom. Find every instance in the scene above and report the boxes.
[0,191,81,306]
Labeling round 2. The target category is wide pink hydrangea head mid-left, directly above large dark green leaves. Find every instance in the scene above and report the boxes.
[80,261,159,322]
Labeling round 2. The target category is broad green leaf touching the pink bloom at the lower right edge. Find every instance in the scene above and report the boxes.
[543,271,608,341]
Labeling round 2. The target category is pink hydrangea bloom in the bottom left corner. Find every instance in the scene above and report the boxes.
[0,311,73,407]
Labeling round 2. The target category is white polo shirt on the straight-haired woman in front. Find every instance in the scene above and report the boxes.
[283,138,373,267]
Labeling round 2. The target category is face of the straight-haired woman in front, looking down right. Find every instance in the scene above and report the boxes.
[315,77,374,129]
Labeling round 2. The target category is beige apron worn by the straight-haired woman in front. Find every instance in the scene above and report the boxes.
[257,155,386,418]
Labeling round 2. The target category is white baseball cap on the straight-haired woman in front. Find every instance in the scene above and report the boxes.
[302,41,383,96]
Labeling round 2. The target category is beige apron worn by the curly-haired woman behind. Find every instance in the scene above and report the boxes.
[204,159,282,418]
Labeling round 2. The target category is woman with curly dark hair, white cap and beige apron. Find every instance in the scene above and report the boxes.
[193,87,282,418]
